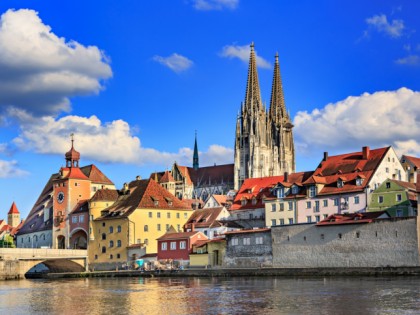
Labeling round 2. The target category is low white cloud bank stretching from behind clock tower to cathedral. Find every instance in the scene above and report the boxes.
[8,109,233,167]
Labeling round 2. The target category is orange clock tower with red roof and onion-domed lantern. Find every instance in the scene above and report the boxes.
[52,134,91,249]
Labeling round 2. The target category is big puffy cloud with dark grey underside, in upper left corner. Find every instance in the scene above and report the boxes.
[0,9,112,115]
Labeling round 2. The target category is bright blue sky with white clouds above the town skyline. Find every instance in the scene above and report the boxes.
[0,0,420,218]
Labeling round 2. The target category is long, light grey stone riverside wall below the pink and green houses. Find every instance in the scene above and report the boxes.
[271,218,419,268]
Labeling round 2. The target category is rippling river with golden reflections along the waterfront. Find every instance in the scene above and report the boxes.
[0,277,420,315]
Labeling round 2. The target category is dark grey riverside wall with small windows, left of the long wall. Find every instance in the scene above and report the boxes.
[223,230,272,268]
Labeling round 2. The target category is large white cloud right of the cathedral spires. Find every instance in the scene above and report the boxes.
[294,88,420,155]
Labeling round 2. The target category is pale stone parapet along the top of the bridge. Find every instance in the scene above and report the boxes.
[0,248,87,260]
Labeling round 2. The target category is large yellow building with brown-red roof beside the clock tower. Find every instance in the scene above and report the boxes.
[88,179,193,265]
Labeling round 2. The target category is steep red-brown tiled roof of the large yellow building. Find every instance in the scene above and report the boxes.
[97,179,191,220]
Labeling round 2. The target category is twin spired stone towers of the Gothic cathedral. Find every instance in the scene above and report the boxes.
[234,43,295,190]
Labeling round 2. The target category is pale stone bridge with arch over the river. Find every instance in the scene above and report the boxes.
[0,248,87,280]
